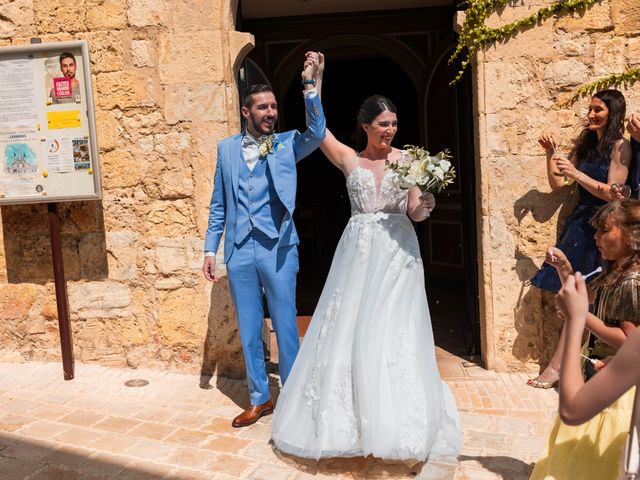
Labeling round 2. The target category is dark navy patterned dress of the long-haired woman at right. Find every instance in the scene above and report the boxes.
[531,147,611,292]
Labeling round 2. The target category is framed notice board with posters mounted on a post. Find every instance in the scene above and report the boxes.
[0,40,101,205]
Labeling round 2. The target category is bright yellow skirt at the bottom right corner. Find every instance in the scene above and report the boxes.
[530,387,635,480]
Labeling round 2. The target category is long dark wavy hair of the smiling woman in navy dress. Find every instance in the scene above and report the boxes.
[570,90,627,163]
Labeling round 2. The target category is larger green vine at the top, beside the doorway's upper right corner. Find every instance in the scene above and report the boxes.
[449,0,601,85]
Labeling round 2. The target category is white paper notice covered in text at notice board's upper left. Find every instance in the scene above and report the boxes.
[0,59,38,129]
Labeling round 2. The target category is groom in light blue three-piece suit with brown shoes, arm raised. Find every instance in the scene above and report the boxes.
[202,52,325,427]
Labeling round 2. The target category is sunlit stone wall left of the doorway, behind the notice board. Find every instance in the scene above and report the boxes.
[0,0,253,376]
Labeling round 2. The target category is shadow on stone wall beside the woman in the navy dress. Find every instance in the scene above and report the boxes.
[511,189,577,368]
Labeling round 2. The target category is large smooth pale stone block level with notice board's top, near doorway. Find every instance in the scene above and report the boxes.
[158,32,225,85]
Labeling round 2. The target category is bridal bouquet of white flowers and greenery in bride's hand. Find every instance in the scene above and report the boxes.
[386,145,456,193]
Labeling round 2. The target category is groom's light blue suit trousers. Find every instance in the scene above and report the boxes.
[227,229,300,405]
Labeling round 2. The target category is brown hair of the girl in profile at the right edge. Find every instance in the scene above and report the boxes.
[591,198,640,287]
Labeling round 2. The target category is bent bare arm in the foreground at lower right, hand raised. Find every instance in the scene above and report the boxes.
[557,274,640,425]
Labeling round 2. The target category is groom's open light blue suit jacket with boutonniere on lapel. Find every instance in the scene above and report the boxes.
[204,91,326,262]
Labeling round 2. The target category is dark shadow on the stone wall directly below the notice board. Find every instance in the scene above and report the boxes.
[1,201,109,284]
